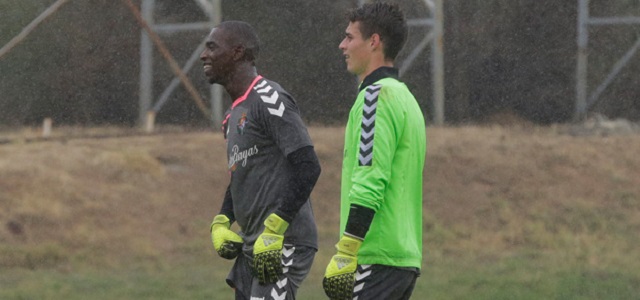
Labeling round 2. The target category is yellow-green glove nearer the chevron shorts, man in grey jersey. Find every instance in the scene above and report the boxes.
[253,214,289,284]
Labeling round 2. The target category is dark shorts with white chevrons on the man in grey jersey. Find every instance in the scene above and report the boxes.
[227,244,317,300]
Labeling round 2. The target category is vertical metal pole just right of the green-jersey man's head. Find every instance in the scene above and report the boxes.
[433,0,444,126]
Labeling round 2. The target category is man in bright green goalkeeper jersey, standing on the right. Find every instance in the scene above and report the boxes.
[323,2,426,300]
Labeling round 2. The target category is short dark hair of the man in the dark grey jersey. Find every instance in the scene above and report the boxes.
[216,21,260,62]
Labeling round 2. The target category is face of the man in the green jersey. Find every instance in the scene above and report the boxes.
[339,22,371,76]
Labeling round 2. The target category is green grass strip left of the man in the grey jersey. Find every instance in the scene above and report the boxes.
[0,265,232,300]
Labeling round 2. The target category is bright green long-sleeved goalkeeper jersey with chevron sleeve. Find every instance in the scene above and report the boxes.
[340,67,427,269]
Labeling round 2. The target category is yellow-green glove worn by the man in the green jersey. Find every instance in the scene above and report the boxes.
[322,235,362,300]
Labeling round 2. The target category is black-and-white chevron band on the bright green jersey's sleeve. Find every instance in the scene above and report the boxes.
[358,85,382,166]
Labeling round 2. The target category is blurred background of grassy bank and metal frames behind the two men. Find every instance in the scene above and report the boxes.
[0,0,640,300]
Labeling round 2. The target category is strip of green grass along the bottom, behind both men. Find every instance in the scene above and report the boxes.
[0,253,640,300]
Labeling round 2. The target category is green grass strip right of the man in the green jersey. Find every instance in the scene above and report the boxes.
[414,256,640,300]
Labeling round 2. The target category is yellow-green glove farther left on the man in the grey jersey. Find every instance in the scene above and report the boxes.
[211,215,242,259]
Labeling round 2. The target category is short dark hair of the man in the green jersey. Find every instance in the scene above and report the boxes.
[347,2,409,60]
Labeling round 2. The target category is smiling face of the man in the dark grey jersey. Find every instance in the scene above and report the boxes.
[200,28,234,85]
